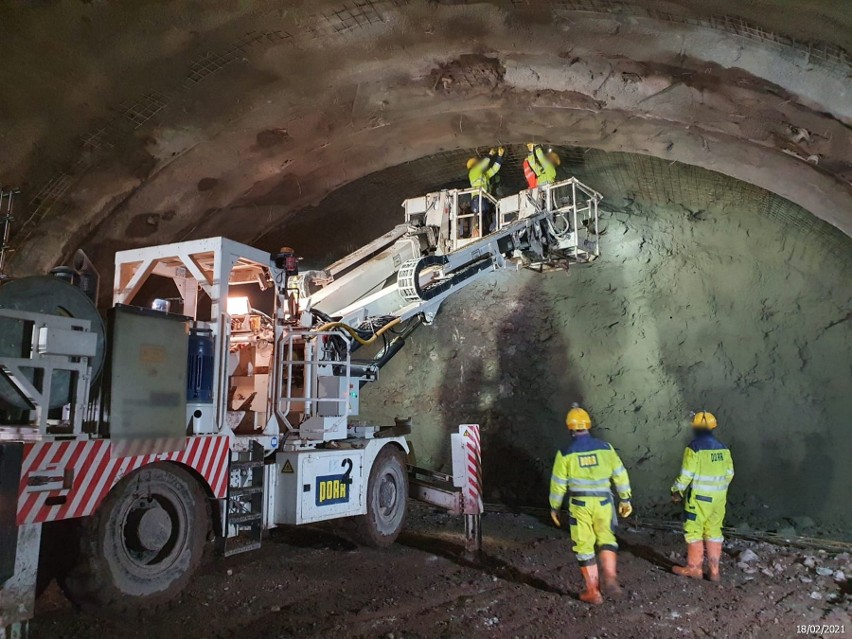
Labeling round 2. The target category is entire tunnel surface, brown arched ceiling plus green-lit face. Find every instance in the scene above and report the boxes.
[0,0,852,537]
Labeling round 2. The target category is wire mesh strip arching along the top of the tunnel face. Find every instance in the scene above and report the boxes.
[296,144,852,263]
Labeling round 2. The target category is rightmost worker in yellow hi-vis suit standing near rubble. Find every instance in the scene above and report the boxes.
[671,411,734,581]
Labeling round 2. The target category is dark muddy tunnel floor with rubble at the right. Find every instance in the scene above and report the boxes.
[32,504,852,639]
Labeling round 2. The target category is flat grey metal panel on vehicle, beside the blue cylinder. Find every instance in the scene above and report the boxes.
[108,307,189,448]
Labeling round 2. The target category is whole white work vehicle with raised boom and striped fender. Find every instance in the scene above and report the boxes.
[0,179,601,637]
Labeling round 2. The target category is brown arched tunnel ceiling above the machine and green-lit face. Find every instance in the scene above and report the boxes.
[0,0,852,272]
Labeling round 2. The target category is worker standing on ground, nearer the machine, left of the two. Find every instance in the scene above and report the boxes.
[550,404,633,604]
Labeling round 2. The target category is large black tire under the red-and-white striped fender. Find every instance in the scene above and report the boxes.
[60,463,210,613]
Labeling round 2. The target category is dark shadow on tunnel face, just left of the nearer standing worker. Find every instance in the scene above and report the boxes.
[439,274,583,506]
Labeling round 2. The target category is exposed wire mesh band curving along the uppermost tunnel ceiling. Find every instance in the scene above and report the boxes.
[6,0,849,270]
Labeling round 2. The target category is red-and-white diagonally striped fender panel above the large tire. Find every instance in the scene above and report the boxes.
[17,435,230,525]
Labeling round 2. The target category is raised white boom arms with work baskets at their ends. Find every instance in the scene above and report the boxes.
[300,178,601,370]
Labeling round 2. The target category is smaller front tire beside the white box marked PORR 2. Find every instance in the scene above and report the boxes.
[354,444,408,547]
